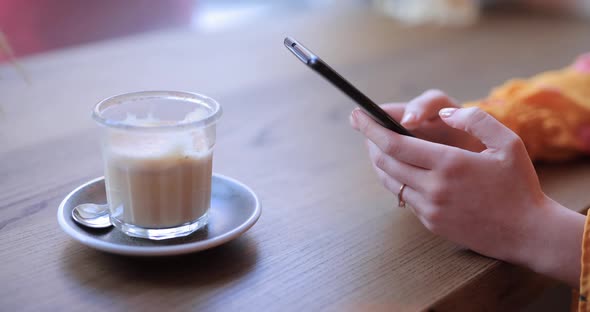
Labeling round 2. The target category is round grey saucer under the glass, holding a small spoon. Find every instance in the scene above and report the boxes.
[57,174,261,256]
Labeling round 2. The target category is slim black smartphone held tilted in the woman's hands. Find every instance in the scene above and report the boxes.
[285,37,414,137]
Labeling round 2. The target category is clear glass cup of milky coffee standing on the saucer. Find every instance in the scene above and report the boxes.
[92,91,221,240]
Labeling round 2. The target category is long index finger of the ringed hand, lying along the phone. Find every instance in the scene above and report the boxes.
[352,111,461,169]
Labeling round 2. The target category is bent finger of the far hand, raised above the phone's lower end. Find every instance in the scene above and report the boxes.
[401,89,458,129]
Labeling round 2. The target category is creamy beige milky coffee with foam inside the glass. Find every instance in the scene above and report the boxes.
[104,111,212,228]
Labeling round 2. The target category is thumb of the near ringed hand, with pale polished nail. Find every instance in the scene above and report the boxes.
[439,107,520,150]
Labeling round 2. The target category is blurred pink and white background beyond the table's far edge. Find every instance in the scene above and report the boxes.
[0,0,590,62]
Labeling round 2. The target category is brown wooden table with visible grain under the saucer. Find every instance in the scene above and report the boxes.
[0,9,590,311]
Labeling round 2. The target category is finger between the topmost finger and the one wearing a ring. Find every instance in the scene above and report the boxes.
[367,140,429,192]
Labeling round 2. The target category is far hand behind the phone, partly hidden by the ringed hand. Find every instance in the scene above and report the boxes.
[381,90,485,152]
